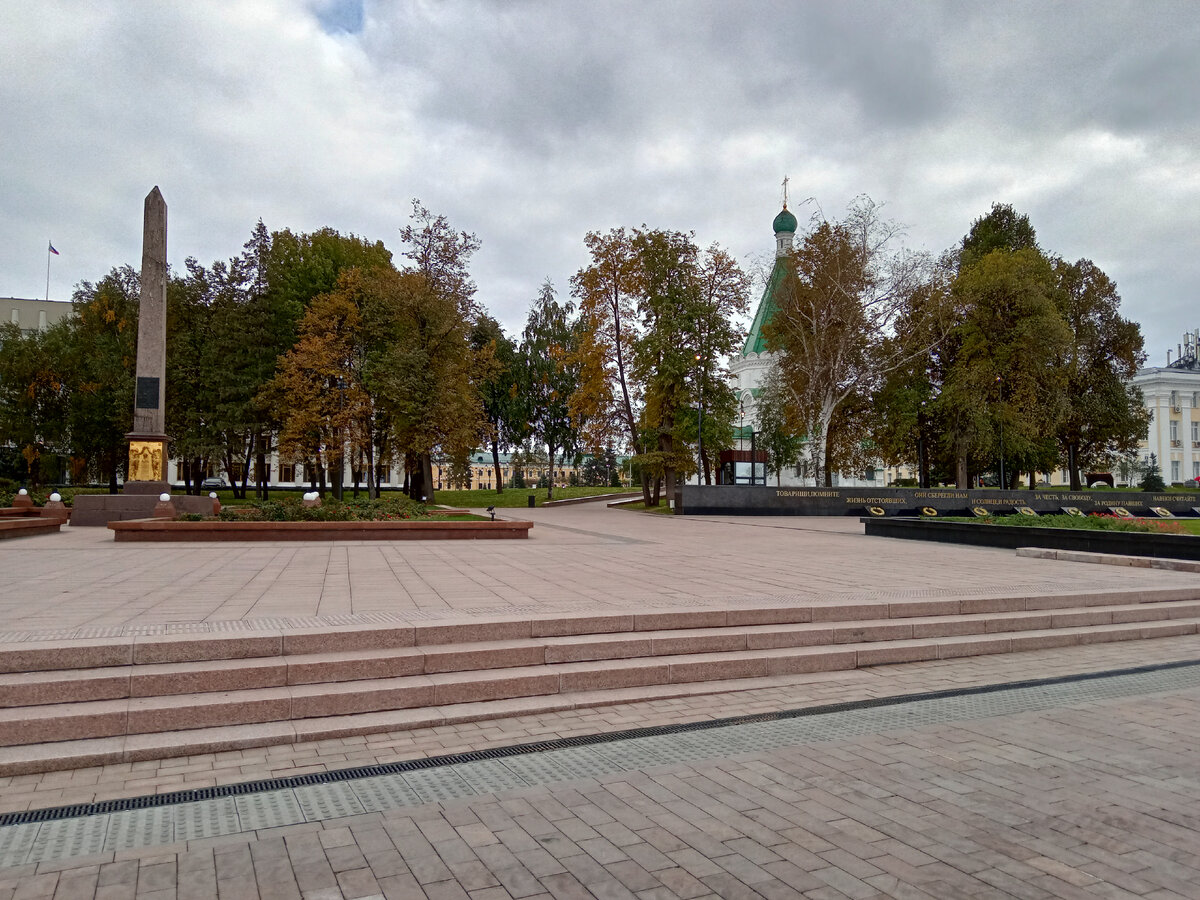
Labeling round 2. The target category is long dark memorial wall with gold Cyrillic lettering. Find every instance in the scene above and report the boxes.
[676,485,1200,517]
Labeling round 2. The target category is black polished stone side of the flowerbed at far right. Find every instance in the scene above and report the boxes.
[859,517,1200,559]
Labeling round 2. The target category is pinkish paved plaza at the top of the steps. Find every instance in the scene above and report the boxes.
[0,504,1195,642]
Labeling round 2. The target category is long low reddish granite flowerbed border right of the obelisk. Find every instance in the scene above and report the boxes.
[108,518,533,541]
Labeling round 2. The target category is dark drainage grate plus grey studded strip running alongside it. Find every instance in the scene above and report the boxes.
[0,660,1200,840]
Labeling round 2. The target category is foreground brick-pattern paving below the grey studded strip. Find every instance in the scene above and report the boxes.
[0,652,1200,900]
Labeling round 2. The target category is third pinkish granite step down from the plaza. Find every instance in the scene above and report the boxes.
[0,617,1200,746]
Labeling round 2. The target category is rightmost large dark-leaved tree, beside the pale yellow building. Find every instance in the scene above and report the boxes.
[1054,259,1150,491]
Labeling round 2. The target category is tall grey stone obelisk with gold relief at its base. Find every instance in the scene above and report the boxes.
[125,185,168,493]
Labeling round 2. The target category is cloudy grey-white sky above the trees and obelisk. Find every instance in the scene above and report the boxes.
[0,0,1200,365]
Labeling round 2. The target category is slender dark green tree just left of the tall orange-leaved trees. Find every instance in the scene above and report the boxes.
[521,278,582,499]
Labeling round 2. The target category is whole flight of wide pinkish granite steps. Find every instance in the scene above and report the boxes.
[0,587,1200,776]
